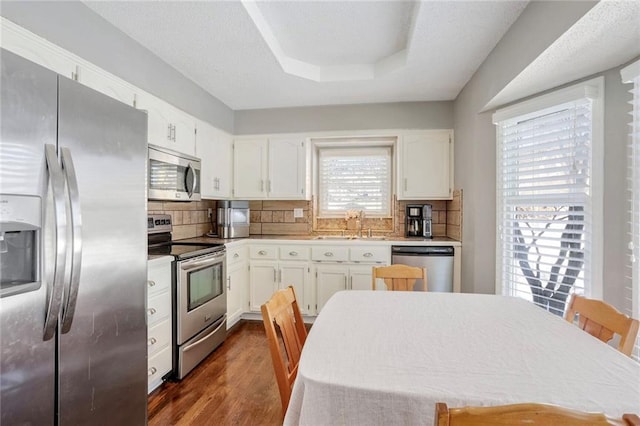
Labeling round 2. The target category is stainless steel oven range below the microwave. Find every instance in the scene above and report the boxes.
[147,215,227,380]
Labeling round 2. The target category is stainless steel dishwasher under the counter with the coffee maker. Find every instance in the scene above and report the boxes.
[391,246,455,293]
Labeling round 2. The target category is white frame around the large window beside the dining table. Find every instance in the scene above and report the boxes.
[493,77,604,306]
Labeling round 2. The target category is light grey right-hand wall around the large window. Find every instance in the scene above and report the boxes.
[454,2,630,309]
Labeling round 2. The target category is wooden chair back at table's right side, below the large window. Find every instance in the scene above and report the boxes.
[565,294,640,356]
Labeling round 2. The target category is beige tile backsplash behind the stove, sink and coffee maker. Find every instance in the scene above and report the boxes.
[148,190,462,240]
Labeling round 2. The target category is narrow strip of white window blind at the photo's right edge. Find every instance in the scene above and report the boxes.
[621,61,640,361]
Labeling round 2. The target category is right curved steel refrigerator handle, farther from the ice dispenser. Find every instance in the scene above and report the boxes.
[60,148,82,333]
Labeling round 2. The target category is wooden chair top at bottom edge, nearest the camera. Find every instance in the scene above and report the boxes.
[433,402,640,426]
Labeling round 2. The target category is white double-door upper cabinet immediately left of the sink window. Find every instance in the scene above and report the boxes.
[233,138,308,200]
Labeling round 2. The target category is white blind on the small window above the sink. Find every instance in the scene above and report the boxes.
[318,147,391,217]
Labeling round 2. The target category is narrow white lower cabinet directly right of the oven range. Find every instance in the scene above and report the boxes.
[227,245,249,329]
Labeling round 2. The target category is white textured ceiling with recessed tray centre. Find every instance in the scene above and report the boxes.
[85,1,527,110]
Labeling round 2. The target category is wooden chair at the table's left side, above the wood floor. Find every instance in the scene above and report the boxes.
[261,286,307,415]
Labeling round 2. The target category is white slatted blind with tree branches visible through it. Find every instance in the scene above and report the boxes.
[494,80,594,315]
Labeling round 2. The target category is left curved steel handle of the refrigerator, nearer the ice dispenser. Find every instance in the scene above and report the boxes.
[43,144,67,340]
